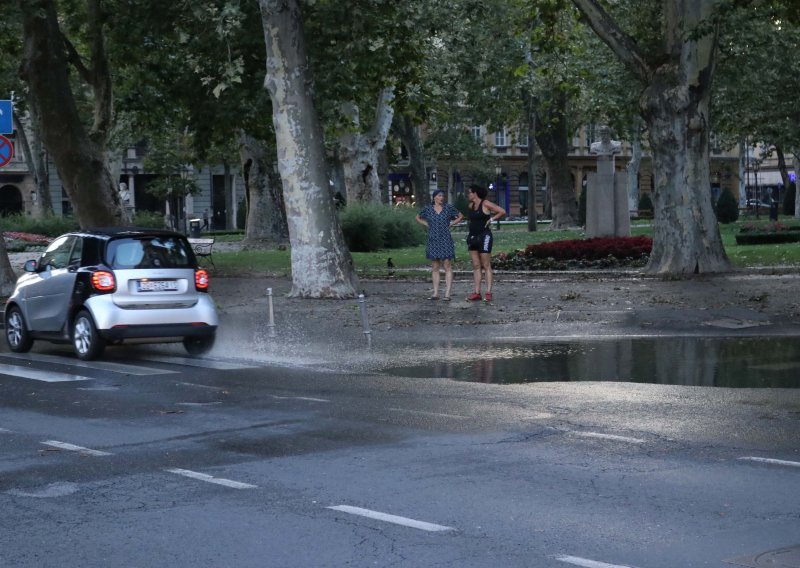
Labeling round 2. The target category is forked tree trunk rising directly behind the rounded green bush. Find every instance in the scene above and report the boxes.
[339,87,394,203]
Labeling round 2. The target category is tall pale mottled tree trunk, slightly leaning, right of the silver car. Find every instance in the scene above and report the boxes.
[259,0,358,298]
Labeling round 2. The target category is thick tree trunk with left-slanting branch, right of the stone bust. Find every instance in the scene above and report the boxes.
[573,0,730,275]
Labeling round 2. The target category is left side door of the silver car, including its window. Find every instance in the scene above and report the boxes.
[25,235,82,332]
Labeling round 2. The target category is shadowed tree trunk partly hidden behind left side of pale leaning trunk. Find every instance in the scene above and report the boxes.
[239,131,289,247]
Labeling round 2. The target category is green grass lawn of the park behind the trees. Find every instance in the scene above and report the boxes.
[214,217,800,277]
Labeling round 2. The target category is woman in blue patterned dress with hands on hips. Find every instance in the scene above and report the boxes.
[416,189,464,302]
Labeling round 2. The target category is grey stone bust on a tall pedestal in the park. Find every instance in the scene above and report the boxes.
[586,126,631,238]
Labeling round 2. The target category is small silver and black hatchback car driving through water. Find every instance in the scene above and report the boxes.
[5,228,218,360]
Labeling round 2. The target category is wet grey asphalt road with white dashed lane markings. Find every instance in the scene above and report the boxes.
[0,346,800,568]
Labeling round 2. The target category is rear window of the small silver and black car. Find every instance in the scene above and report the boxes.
[106,236,195,269]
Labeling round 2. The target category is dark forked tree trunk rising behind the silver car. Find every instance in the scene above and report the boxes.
[19,0,127,228]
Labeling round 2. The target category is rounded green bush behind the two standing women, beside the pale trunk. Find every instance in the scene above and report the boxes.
[339,203,425,252]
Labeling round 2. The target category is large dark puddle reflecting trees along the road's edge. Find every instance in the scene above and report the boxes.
[384,337,800,388]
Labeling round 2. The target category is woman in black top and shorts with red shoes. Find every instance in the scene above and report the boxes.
[467,185,506,302]
